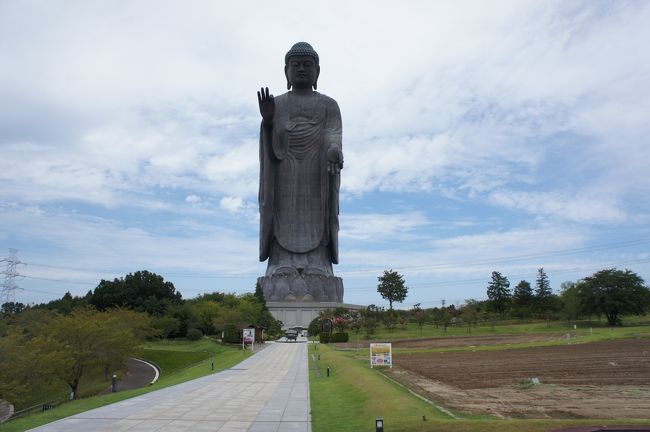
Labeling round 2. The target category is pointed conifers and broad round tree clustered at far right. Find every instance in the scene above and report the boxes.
[487,268,650,325]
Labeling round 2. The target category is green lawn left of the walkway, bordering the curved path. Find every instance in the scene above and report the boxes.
[0,339,251,432]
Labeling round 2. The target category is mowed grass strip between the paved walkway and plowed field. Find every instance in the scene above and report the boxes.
[309,344,650,432]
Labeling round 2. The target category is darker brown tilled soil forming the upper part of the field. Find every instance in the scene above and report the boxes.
[395,339,650,389]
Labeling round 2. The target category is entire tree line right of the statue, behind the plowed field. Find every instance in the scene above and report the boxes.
[309,268,650,337]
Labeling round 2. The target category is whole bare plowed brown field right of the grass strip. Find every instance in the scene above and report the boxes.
[387,339,650,419]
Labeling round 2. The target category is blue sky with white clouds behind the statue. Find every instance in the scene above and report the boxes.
[0,0,650,307]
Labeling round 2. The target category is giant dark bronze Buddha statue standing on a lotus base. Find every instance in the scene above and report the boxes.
[257,42,343,302]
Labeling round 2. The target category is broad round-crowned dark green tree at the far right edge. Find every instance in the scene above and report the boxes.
[577,269,650,326]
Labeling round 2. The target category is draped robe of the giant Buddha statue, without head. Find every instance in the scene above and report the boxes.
[259,92,341,276]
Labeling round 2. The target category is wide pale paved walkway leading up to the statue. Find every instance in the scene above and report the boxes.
[32,343,311,432]
